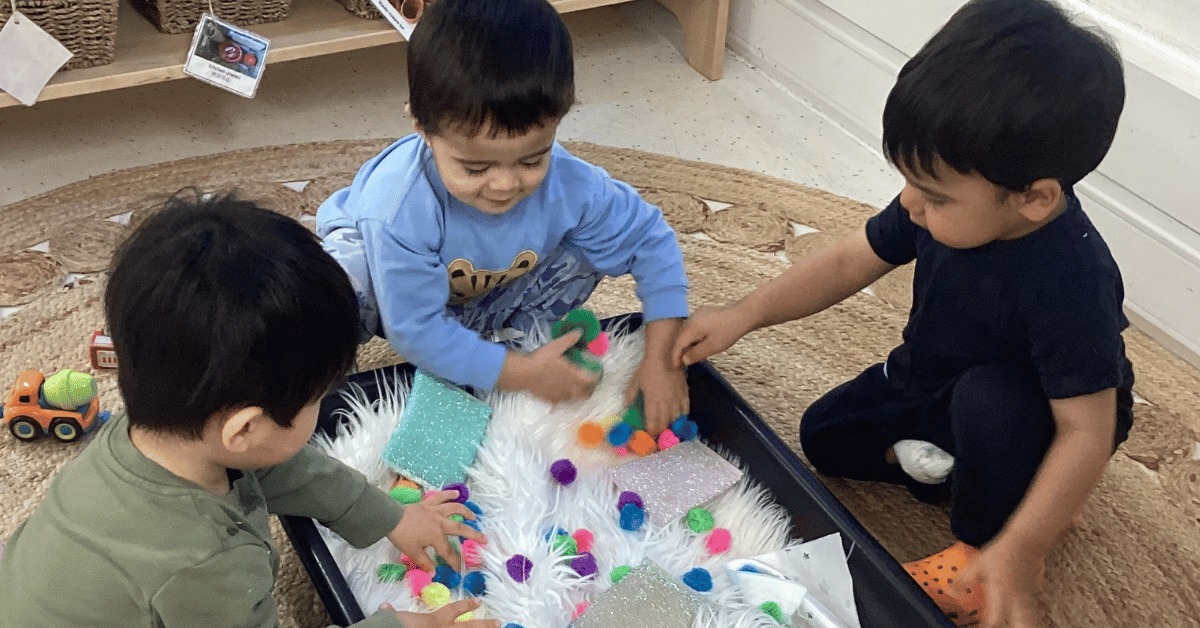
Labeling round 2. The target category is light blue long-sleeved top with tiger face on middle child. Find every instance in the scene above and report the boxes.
[317,134,688,389]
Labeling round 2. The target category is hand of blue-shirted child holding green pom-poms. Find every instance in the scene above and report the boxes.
[497,329,600,403]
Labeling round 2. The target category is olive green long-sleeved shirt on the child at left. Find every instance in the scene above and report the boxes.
[0,417,402,628]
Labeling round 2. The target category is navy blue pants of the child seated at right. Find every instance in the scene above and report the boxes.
[800,364,1133,548]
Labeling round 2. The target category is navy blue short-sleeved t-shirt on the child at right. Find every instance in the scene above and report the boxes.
[866,195,1133,399]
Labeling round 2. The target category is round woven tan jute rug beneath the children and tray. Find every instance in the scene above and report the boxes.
[0,140,1200,628]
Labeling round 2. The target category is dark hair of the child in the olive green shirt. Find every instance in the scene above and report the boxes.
[104,190,359,438]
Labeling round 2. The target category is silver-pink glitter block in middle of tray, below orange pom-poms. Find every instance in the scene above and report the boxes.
[611,441,742,526]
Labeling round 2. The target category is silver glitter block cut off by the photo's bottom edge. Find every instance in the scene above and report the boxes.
[571,560,708,628]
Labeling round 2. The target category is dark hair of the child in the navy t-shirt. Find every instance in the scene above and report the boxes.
[883,0,1124,191]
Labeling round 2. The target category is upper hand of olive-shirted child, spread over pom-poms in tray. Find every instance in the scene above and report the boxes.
[388,491,487,573]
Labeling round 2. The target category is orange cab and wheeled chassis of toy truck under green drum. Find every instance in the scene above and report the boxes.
[0,371,108,443]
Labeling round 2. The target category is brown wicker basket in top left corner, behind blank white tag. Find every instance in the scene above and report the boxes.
[0,0,118,70]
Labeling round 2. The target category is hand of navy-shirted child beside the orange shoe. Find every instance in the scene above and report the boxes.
[952,536,1045,628]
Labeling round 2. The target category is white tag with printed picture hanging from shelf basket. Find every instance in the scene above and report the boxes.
[184,13,271,98]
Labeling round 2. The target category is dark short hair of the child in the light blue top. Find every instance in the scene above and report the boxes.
[408,0,575,137]
